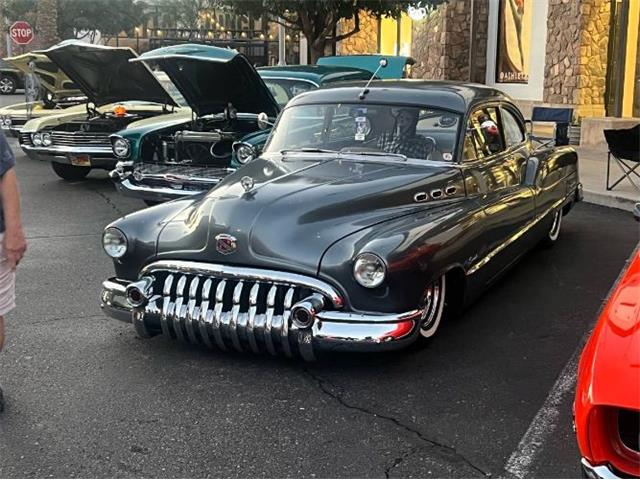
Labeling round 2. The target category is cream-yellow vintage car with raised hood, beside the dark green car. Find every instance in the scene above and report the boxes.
[19,40,191,180]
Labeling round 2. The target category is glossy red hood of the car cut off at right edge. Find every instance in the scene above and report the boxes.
[582,248,640,410]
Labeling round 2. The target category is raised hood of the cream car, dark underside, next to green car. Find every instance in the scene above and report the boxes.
[40,41,176,105]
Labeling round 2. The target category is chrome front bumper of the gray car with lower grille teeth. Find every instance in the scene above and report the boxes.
[101,278,422,361]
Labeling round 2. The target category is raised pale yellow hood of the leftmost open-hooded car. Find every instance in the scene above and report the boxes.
[4,52,84,99]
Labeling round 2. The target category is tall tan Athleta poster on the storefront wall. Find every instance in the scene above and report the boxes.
[496,0,533,83]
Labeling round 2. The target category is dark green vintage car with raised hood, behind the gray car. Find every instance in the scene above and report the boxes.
[111,45,406,204]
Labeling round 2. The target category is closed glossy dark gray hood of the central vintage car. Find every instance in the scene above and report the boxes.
[158,154,464,275]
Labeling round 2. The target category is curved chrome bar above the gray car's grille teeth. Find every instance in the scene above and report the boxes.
[140,260,344,308]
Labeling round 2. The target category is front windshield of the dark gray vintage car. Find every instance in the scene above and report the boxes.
[265,103,460,162]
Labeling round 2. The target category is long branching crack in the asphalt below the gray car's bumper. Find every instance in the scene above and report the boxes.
[303,368,491,478]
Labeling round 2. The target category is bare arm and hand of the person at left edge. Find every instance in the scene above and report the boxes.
[0,168,27,268]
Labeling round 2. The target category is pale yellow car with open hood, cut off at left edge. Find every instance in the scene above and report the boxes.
[0,52,86,137]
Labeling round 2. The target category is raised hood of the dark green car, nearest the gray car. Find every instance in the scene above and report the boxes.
[134,44,280,117]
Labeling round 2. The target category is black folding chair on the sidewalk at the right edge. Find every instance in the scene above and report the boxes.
[604,124,640,191]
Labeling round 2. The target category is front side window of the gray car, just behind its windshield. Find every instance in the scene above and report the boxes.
[463,107,504,160]
